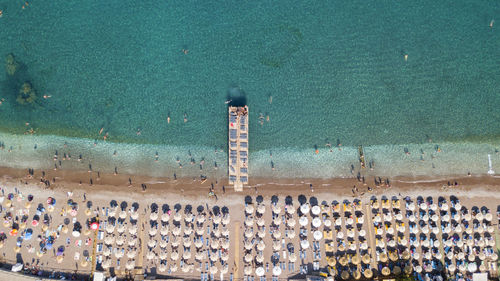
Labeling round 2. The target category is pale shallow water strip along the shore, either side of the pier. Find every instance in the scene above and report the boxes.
[0,133,500,178]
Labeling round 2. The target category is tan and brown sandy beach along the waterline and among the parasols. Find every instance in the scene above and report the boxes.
[0,165,500,280]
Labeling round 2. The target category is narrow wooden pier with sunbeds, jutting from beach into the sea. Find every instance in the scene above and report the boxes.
[228,106,248,191]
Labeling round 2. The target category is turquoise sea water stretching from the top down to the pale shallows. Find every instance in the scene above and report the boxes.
[0,0,500,177]
